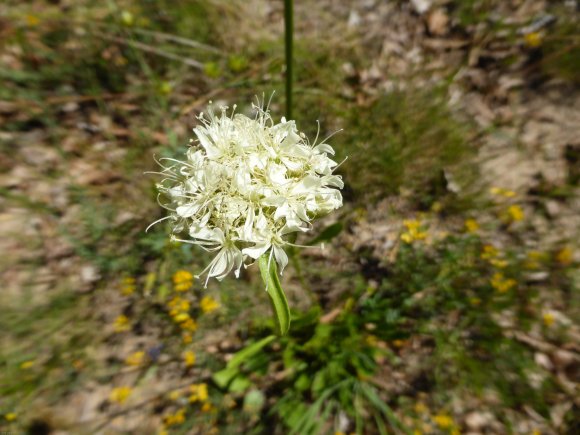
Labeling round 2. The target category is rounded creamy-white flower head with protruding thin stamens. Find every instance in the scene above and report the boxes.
[151,103,343,285]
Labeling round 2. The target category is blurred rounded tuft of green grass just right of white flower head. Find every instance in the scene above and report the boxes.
[339,88,475,204]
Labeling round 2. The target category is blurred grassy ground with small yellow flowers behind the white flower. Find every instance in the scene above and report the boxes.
[0,0,580,434]
